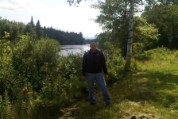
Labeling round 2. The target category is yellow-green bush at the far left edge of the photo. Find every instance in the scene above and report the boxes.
[0,39,18,99]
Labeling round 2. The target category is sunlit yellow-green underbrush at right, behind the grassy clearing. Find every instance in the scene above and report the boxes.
[134,47,178,70]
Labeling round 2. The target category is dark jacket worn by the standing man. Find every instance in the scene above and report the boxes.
[82,49,108,76]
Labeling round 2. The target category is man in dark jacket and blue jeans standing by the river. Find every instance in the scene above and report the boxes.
[82,42,110,105]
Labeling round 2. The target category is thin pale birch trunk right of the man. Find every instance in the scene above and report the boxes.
[125,0,134,71]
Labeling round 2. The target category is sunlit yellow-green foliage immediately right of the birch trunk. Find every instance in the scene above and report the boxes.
[133,17,159,55]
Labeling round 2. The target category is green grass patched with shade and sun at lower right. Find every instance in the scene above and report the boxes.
[60,60,178,119]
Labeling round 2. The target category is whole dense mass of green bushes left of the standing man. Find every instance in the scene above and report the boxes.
[0,35,88,118]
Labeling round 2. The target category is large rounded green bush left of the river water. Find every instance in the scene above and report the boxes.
[12,39,59,91]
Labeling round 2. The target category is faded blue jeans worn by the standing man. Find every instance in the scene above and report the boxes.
[87,73,110,103]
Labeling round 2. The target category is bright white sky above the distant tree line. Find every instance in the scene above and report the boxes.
[0,0,102,38]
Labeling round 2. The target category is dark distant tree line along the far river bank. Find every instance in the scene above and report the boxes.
[0,17,85,45]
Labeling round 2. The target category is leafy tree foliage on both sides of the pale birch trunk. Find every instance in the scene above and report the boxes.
[96,0,159,57]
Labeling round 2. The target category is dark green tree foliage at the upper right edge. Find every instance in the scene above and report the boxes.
[143,4,178,48]
